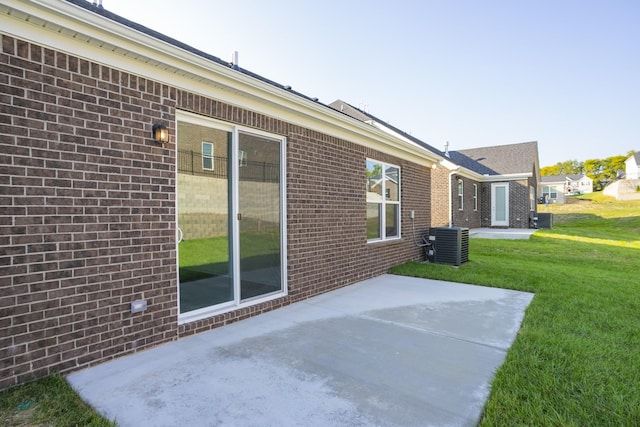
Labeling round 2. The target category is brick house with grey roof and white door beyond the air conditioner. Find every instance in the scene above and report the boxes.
[329,100,540,228]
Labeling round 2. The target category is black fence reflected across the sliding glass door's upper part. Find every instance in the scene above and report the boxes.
[178,150,280,182]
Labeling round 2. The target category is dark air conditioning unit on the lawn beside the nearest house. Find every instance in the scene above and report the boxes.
[427,227,469,265]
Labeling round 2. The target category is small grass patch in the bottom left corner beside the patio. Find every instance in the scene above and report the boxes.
[0,375,116,427]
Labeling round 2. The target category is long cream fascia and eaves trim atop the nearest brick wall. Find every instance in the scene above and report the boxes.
[0,0,439,166]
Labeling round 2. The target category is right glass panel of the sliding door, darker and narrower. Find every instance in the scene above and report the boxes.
[238,132,282,300]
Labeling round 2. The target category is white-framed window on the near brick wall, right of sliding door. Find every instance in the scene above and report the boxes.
[367,160,400,241]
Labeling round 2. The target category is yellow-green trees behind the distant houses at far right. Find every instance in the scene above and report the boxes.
[540,151,636,191]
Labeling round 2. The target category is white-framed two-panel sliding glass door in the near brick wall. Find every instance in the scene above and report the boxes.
[177,120,286,319]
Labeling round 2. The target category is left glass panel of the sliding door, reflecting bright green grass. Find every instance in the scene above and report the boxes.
[177,122,234,313]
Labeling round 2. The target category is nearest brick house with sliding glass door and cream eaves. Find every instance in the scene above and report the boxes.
[0,0,442,389]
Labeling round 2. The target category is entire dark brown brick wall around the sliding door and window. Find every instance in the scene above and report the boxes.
[0,36,431,389]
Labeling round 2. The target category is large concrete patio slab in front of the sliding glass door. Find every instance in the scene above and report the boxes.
[68,275,533,427]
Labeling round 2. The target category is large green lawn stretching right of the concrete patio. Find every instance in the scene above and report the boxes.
[392,195,640,426]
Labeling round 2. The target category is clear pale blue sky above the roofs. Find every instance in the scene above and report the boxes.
[103,0,640,166]
